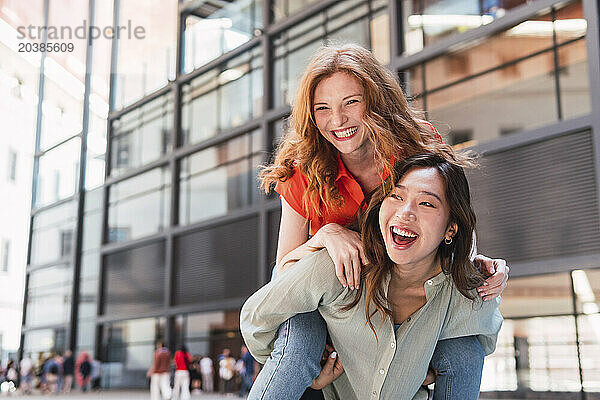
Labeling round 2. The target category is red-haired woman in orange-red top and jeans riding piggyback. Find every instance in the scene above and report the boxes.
[249,45,508,400]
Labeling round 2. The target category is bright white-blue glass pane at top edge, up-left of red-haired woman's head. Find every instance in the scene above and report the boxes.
[184,0,262,73]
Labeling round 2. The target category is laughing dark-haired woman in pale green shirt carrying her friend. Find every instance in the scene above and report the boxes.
[241,154,502,400]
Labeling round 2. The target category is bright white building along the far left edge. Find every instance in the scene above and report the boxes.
[0,14,39,366]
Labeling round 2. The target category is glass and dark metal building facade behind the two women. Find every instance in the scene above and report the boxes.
[21,0,600,399]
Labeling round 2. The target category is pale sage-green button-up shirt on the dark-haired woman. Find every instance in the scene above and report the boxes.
[240,249,502,400]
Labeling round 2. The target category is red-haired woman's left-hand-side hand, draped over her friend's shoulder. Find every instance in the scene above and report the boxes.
[313,223,367,290]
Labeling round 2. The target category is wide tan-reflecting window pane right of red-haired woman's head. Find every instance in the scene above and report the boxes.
[426,51,558,144]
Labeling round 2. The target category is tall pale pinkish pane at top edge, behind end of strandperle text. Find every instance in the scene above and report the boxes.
[115,0,178,109]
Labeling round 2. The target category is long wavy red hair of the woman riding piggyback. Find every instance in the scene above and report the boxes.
[259,44,453,216]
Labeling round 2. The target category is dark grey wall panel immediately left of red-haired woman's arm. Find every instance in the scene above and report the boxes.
[174,217,258,305]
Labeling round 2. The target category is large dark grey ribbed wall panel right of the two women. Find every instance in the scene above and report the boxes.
[469,131,600,263]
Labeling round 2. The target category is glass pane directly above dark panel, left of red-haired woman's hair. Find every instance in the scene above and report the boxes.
[179,131,262,224]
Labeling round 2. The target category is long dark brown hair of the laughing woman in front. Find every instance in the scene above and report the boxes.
[343,153,485,337]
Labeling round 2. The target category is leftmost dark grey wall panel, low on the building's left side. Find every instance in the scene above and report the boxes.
[104,242,166,315]
